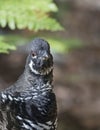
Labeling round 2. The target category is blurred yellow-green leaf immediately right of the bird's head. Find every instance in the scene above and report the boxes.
[47,37,82,53]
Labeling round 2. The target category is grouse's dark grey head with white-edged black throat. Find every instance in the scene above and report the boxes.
[27,38,53,75]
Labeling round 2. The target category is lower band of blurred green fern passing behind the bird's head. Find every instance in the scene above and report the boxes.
[0,34,82,53]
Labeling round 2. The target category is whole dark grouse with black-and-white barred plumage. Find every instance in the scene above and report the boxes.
[0,38,57,130]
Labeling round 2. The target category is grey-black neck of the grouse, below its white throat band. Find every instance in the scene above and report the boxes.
[24,67,53,90]
